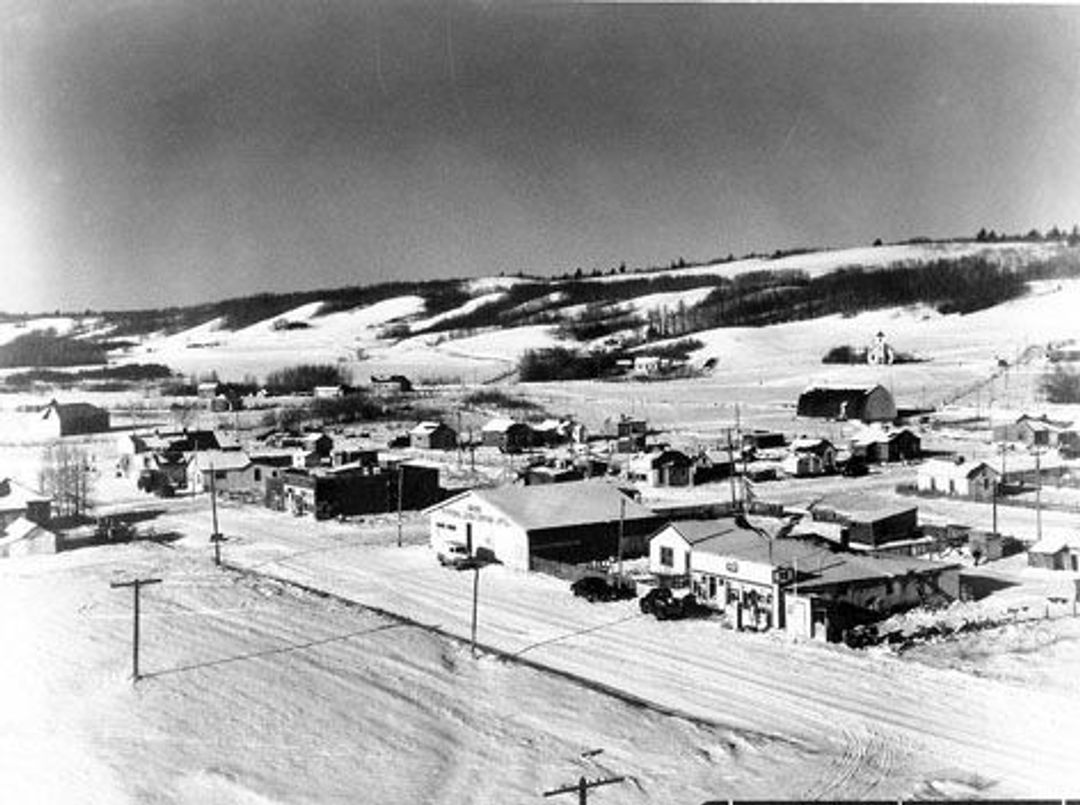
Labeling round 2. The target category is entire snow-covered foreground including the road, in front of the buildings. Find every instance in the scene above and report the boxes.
[8,500,1080,803]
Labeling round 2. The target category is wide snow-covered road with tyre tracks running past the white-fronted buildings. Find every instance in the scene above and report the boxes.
[161,501,1080,797]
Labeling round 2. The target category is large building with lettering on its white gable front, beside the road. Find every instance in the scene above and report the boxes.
[427,481,663,571]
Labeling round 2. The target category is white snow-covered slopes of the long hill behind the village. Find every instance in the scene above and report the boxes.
[0,236,1080,391]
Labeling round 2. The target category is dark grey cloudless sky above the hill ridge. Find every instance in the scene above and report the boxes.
[0,0,1080,312]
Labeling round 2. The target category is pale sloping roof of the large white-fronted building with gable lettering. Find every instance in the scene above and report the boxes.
[468,481,657,531]
